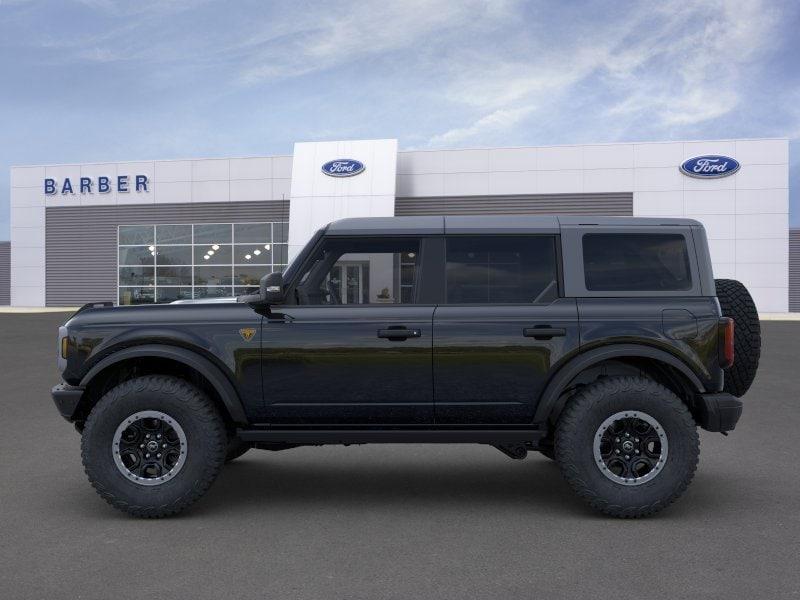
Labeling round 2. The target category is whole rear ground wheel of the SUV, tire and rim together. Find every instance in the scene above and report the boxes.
[555,377,700,518]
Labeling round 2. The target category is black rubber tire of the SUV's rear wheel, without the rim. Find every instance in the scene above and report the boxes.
[555,377,700,518]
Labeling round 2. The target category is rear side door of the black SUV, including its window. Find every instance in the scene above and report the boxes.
[433,235,579,424]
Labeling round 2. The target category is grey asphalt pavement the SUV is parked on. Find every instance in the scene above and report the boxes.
[0,314,800,600]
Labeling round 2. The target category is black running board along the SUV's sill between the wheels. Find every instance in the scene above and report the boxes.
[237,429,545,445]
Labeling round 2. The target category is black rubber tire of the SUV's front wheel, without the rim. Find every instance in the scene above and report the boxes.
[81,375,227,518]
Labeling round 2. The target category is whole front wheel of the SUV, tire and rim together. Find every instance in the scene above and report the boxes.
[81,375,227,518]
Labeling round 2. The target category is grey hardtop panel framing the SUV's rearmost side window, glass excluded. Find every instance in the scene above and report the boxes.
[561,225,702,298]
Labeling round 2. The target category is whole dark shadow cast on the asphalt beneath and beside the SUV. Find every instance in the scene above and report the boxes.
[59,449,742,522]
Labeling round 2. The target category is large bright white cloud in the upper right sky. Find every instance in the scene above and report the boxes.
[422,0,779,144]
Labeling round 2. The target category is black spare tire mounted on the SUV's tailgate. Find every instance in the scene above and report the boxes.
[714,279,761,396]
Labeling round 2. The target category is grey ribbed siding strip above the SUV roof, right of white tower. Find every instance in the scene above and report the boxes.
[394,193,633,216]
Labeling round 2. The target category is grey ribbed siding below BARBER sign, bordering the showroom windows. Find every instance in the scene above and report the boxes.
[45,200,289,306]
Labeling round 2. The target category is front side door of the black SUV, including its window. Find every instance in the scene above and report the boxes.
[262,237,435,425]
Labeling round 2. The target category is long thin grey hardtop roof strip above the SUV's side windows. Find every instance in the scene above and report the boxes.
[326,215,700,235]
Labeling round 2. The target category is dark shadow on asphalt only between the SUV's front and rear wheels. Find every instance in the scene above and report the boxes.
[191,450,591,515]
